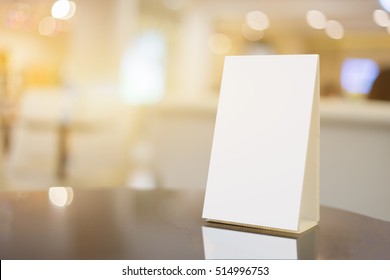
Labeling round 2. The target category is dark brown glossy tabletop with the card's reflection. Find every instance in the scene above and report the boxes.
[0,188,390,260]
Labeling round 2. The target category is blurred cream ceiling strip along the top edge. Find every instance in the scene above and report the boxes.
[0,0,388,35]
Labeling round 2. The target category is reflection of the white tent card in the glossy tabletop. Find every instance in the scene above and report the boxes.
[202,223,318,260]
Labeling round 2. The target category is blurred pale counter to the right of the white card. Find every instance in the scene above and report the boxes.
[321,101,390,221]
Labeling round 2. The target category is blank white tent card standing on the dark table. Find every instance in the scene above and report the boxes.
[203,55,320,233]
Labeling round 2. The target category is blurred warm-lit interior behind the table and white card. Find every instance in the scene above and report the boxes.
[0,0,390,220]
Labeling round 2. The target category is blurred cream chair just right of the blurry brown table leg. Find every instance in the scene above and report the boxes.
[65,96,135,187]
